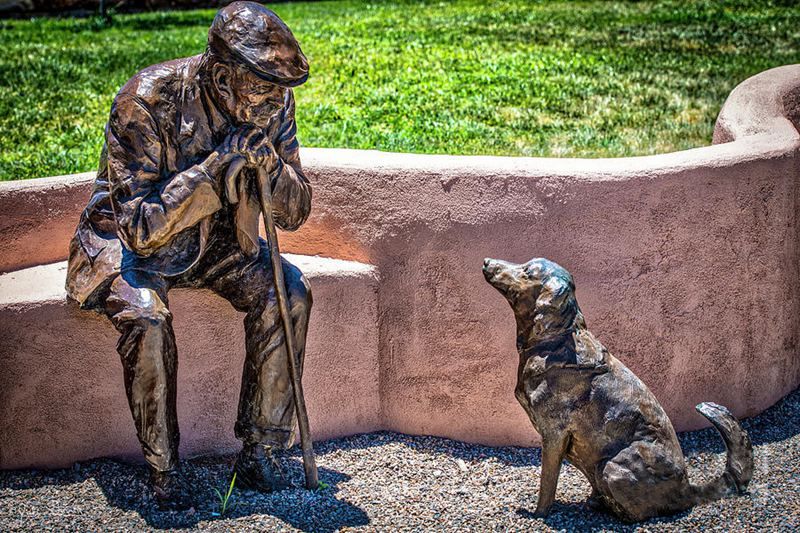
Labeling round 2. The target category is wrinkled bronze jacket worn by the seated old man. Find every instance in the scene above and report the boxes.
[66,56,311,307]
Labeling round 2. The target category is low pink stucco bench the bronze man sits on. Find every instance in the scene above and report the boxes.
[0,256,382,468]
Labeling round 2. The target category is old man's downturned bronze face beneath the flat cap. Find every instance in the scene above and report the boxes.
[220,63,286,128]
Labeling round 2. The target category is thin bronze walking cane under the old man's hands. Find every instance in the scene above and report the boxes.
[257,168,319,489]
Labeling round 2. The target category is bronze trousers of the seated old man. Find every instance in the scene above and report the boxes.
[105,241,312,471]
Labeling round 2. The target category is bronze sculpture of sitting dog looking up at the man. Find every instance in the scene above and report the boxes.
[483,259,753,521]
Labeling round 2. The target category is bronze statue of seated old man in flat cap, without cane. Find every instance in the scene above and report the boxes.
[67,2,311,508]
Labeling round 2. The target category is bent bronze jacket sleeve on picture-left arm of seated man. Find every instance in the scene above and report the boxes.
[106,96,222,256]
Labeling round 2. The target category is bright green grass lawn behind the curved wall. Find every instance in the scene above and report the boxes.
[0,0,800,180]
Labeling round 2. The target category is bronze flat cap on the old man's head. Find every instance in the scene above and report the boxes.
[208,2,308,87]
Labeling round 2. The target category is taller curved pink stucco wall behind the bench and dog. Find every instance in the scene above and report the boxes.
[0,65,800,450]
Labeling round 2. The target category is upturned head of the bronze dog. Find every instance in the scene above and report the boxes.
[483,258,583,339]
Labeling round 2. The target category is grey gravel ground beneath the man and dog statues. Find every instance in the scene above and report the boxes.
[0,389,800,531]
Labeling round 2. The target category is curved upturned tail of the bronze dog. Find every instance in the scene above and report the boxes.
[692,402,753,503]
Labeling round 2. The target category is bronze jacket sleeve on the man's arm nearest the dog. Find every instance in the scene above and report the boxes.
[272,90,311,231]
